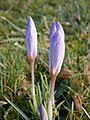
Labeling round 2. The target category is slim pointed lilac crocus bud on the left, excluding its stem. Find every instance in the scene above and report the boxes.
[26,17,37,60]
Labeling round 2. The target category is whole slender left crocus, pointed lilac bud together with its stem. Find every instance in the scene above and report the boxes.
[26,17,39,115]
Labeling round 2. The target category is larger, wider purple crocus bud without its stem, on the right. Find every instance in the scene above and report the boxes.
[49,22,65,75]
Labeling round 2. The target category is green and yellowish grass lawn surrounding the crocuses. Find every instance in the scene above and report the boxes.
[0,0,90,120]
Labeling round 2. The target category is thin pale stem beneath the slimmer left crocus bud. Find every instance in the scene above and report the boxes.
[30,60,39,115]
